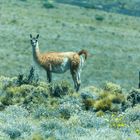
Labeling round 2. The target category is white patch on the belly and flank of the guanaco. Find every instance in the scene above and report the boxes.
[51,58,70,73]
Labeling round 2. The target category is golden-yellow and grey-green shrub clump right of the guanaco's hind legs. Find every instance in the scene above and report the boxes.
[81,83,126,112]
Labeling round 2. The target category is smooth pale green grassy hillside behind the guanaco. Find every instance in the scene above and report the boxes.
[0,0,140,88]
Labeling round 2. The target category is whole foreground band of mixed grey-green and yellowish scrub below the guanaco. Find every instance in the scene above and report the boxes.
[0,71,140,140]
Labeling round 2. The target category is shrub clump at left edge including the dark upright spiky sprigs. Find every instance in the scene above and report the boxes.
[0,70,49,107]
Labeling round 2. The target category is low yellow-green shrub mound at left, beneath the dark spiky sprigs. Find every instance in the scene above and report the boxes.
[0,85,48,105]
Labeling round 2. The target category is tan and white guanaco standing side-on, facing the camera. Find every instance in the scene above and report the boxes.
[30,34,87,91]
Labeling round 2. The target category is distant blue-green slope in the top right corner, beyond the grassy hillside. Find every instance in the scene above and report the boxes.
[56,0,140,16]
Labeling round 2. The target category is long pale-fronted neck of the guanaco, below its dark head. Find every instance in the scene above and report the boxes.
[32,42,41,65]
